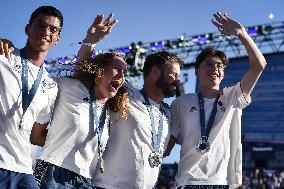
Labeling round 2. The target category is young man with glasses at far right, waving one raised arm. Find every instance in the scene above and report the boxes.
[165,13,266,189]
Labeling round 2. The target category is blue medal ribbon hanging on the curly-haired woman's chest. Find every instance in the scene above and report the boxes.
[89,87,107,157]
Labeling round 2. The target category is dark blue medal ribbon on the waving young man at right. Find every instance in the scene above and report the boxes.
[197,92,220,141]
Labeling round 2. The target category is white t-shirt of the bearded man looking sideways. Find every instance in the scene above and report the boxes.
[94,86,170,189]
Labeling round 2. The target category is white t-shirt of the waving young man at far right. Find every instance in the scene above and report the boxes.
[171,83,250,186]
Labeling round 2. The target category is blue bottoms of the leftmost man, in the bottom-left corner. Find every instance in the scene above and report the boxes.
[0,168,39,189]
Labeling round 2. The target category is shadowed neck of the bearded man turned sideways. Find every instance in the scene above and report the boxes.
[143,82,164,103]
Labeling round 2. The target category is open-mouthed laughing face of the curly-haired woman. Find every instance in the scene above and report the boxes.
[95,56,126,98]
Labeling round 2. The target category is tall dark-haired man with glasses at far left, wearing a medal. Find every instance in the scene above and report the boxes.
[0,6,63,189]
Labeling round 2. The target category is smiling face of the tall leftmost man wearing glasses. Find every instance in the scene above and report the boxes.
[25,14,61,52]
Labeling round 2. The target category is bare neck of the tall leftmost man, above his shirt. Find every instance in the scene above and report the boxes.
[23,43,47,67]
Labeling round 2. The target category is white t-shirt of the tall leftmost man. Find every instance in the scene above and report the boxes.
[0,49,57,174]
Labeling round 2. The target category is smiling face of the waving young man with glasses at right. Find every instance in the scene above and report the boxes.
[196,56,225,89]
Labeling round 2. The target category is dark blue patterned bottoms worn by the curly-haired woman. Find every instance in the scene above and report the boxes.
[34,160,96,189]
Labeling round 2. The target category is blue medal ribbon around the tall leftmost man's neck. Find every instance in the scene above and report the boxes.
[20,49,43,125]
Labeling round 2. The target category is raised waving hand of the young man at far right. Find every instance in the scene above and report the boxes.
[211,12,246,36]
